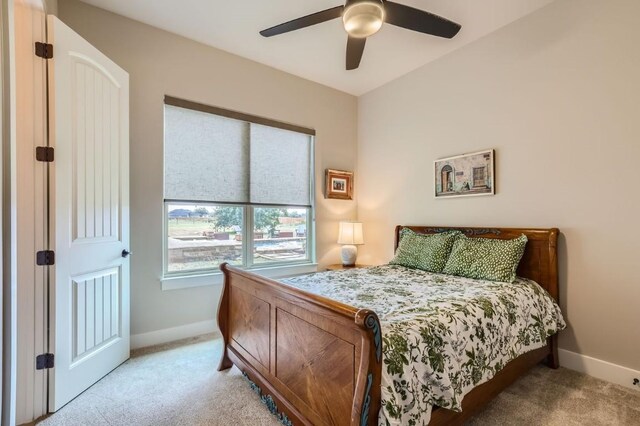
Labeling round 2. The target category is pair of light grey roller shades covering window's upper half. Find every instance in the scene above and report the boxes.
[164,105,313,206]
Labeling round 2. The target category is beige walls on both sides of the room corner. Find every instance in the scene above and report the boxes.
[59,0,640,369]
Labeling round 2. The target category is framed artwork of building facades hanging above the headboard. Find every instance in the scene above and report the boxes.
[434,149,495,198]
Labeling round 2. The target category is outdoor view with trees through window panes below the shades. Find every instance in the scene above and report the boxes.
[167,204,308,272]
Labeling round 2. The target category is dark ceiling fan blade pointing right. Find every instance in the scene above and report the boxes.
[384,1,462,38]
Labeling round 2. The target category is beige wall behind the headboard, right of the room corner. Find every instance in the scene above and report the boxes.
[357,0,640,370]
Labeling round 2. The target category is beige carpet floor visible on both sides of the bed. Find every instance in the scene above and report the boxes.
[37,336,640,426]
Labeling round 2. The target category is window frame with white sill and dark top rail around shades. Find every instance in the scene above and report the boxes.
[160,96,317,282]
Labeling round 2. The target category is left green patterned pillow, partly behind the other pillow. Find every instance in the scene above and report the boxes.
[389,228,460,272]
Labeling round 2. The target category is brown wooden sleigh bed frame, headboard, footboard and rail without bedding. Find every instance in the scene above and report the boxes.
[218,226,558,426]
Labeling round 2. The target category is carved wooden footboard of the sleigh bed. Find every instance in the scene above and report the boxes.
[218,264,382,426]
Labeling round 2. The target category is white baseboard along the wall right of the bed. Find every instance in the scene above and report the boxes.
[558,349,640,390]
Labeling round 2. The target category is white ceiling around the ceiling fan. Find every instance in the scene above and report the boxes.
[76,0,553,95]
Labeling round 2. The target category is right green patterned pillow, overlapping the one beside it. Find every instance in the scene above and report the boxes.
[442,234,527,283]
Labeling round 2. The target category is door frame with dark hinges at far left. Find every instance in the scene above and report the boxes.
[2,0,49,424]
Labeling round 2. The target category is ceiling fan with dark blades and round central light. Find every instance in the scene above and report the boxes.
[260,0,462,70]
